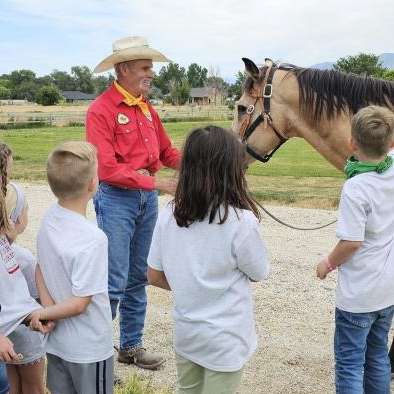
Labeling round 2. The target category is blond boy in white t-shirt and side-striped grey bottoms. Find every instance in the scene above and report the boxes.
[31,141,113,394]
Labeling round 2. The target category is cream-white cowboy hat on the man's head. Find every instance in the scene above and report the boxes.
[93,36,171,73]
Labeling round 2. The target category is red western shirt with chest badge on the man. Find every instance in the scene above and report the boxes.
[86,85,180,190]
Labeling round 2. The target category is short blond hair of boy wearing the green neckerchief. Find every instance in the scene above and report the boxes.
[352,105,394,158]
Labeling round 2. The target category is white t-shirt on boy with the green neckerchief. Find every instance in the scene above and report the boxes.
[336,151,394,313]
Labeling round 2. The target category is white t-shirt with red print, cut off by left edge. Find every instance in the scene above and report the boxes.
[0,235,41,336]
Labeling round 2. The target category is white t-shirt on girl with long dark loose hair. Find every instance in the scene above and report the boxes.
[148,204,269,372]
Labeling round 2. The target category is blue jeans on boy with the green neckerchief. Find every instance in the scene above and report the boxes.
[334,306,394,394]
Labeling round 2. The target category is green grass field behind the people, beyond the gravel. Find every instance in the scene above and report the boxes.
[0,122,344,208]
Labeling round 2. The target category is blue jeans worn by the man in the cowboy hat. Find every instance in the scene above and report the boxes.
[94,182,158,349]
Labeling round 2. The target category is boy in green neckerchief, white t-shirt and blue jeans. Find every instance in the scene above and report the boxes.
[317,106,394,394]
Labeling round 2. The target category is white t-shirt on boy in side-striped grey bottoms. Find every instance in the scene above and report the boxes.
[37,204,113,363]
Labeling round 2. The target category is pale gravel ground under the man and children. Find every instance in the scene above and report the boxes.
[18,184,394,394]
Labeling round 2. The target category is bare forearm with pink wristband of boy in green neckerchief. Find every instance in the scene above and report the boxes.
[316,240,362,279]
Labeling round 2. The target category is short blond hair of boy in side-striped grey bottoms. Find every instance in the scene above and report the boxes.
[47,141,97,200]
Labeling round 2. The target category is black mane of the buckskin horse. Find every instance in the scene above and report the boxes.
[245,67,394,122]
